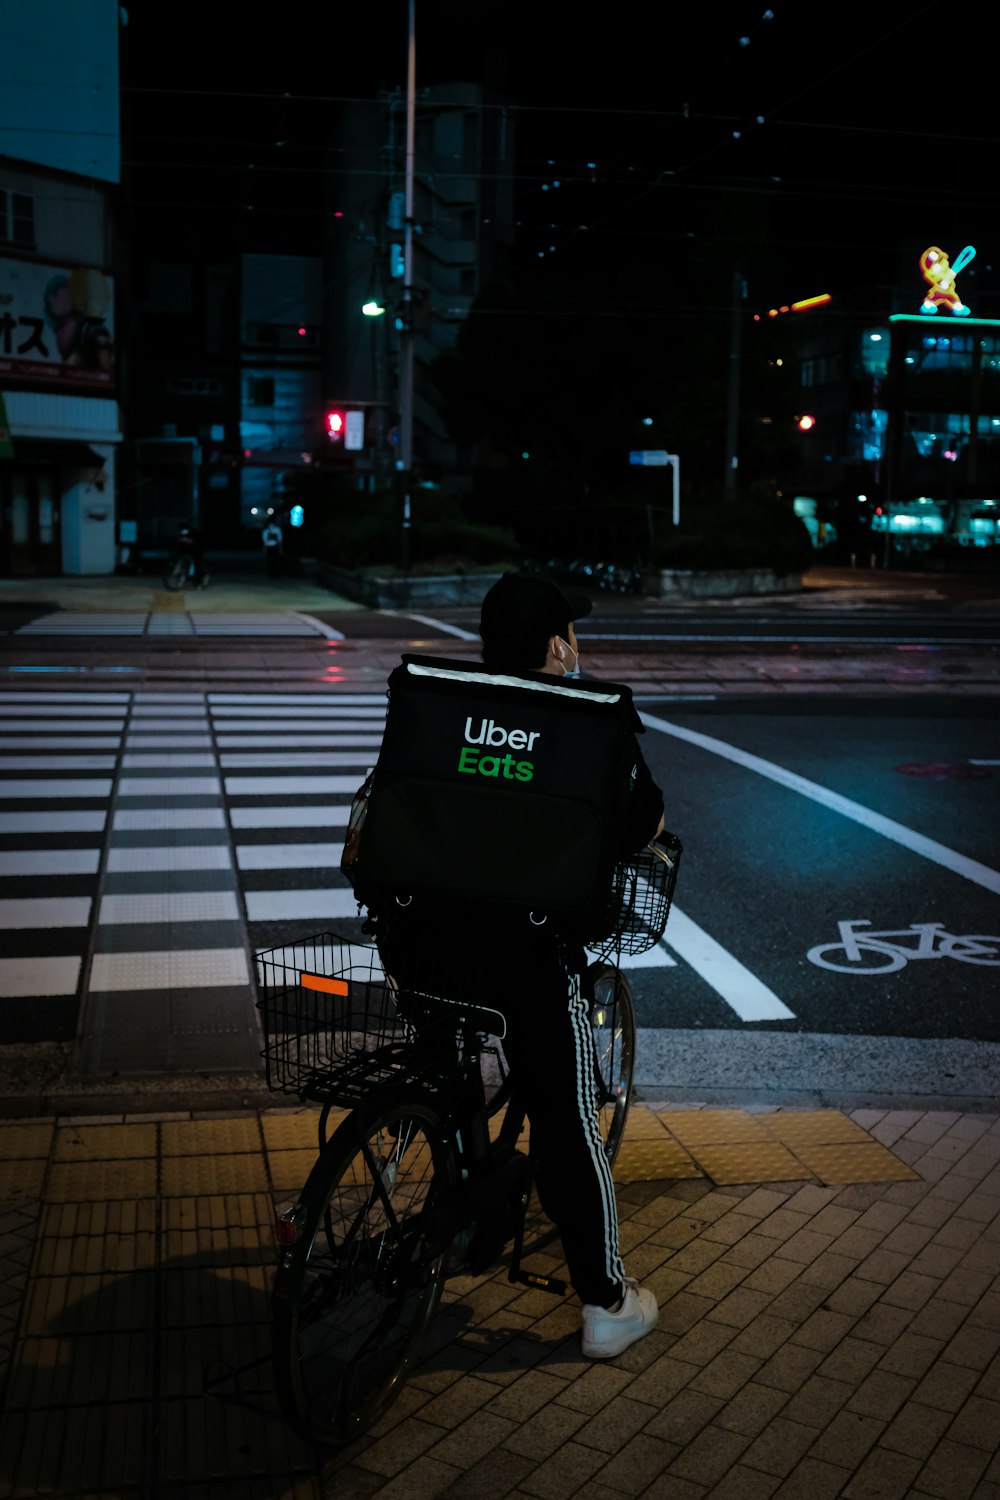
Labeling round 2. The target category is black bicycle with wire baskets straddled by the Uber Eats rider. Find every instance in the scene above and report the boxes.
[256,834,681,1448]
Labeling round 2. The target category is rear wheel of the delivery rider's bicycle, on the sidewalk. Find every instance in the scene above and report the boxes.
[271,1100,454,1446]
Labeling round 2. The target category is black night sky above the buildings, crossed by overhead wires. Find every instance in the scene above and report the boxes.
[123,0,1000,315]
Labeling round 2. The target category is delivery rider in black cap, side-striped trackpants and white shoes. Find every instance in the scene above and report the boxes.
[375,573,664,1359]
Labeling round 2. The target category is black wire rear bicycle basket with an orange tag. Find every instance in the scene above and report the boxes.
[255,933,408,1103]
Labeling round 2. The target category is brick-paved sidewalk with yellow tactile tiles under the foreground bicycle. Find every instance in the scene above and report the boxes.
[0,1103,1000,1500]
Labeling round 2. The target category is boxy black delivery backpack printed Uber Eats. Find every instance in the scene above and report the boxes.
[340,656,636,935]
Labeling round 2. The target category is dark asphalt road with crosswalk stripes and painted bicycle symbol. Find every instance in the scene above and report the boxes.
[0,570,1000,1104]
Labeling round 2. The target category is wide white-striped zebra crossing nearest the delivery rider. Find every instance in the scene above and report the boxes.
[0,690,675,1073]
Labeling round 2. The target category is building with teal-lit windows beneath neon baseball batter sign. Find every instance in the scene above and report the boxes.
[753,248,1000,566]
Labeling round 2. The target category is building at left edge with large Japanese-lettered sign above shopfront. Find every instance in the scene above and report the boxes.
[0,0,123,576]
